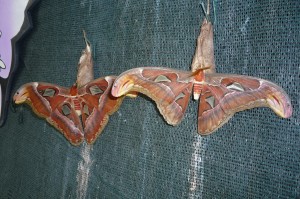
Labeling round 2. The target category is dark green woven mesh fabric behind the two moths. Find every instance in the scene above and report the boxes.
[0,0,300,198]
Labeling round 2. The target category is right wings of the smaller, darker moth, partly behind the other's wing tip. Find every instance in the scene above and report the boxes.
[78,76,123,144]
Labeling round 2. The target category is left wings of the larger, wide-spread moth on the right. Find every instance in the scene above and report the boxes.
[112,67,193,125]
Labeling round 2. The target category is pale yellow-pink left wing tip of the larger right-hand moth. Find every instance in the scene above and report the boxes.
[111,77,134,97]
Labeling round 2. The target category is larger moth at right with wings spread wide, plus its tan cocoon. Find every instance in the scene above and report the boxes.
[112,0,292,135]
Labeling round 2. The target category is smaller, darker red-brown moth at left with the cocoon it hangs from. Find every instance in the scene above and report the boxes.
[13,34,123,145]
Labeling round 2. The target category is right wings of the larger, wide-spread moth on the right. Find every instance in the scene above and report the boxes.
[198,74,292,135]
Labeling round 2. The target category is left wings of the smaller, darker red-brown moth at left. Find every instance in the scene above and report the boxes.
[14,82,83,145]
